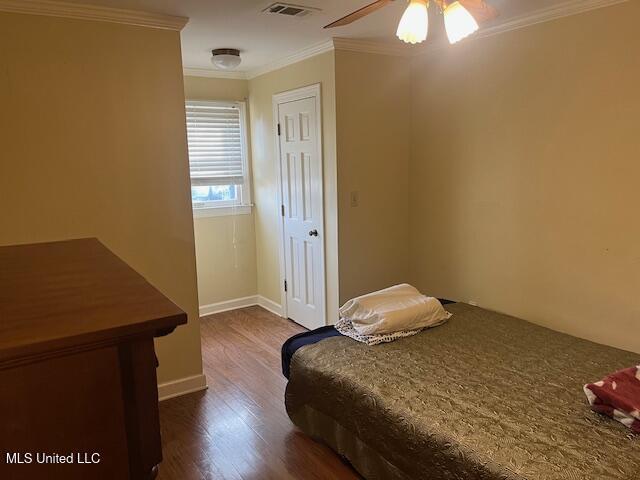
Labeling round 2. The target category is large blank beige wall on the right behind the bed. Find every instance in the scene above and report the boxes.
[409,2,640,352]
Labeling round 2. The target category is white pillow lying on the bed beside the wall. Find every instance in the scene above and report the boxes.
[340,283,451,335]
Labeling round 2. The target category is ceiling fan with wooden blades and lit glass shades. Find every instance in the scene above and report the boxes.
[324,0,498,44]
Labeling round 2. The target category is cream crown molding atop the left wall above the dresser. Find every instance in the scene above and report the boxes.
[0,0,189,31]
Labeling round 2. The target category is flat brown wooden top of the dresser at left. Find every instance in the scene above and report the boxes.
[0,238,187,360]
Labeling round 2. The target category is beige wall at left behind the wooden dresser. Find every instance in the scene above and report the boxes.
[0,13,202,382]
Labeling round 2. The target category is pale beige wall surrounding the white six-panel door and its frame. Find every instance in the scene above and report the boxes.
[249,52,338,321]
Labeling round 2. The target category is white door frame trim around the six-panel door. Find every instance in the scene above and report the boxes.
[272,83,327,325]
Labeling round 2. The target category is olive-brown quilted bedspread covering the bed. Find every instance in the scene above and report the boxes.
[285,303,640,480]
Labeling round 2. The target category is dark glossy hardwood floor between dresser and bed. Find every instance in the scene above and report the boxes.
[158,307,361,480]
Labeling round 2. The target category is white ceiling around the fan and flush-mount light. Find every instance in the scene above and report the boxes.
[56,0,600,72]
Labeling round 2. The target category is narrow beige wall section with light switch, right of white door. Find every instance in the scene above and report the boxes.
[336,50,411,303]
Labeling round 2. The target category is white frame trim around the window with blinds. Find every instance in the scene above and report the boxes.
[185,99,253,218]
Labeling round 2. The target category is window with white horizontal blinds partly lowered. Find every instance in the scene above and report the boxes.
[186,101,251,215]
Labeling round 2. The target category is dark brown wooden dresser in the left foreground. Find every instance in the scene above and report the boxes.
[0,239,187,480]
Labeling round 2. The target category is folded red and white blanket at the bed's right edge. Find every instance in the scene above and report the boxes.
[584,365,640,433]
